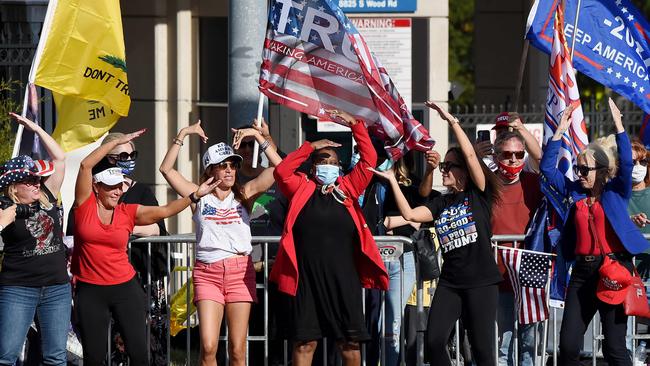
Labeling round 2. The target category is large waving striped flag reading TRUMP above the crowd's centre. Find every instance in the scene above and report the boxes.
[260,0,434,159]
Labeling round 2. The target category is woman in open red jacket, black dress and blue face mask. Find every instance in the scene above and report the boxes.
[271,110,388,366]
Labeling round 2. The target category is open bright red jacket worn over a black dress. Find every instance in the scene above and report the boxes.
[270,121,388,296]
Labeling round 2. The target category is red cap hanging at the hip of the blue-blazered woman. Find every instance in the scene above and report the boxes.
[596,257,632,305]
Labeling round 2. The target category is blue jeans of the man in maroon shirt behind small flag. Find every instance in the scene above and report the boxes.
[497,291,536,366]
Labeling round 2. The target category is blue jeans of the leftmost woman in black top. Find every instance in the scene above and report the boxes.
[0,283,72,366]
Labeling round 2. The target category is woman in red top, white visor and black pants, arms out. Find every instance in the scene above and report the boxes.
[72,130,219,365]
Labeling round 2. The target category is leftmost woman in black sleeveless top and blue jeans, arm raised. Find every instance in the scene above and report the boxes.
[0,113,67,365]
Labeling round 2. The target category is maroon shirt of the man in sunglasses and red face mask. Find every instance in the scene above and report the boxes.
[492,172,544,292]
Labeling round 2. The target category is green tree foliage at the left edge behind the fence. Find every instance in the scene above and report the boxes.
[0,79,21,162]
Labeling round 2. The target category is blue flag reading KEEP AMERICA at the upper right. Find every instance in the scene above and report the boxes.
[526,0,650,113]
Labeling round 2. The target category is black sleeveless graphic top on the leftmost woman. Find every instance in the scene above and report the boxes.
[0,186,70,287]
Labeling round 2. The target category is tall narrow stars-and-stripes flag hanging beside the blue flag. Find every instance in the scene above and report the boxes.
[544,1,589,180]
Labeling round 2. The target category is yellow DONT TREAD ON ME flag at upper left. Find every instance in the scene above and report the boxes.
[30,0,131,151]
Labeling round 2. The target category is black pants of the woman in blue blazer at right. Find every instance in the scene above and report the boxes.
[559,260,632,366]
